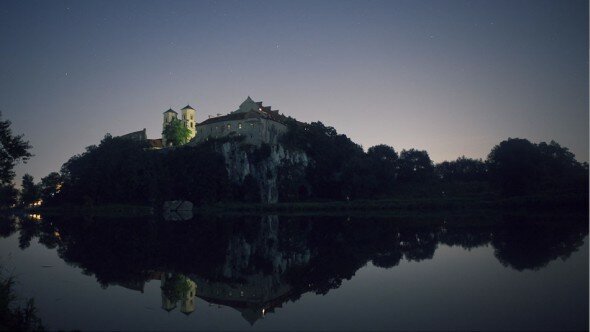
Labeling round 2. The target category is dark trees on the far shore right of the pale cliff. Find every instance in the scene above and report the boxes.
[280,119,588,200]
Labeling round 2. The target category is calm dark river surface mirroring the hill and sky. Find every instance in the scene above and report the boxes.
[0,216,589,330]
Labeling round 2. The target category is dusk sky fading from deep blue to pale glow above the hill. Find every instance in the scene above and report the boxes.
[0,0,589,183]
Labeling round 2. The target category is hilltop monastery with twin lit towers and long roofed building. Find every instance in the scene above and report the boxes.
[121,96,287,148]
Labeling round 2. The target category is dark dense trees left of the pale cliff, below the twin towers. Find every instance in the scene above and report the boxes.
[53,135,231,205]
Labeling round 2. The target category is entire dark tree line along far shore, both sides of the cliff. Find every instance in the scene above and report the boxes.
[0,113,588,207]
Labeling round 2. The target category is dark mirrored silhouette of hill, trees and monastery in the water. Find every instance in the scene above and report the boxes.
[0,216,588,323]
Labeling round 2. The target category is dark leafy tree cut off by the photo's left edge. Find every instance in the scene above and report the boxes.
[0,112,33,208]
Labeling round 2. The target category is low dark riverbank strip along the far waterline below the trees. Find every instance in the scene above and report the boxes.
[20,189,588,217]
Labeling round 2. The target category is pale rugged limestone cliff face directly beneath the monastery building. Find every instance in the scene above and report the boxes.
[216,141,310,203]
